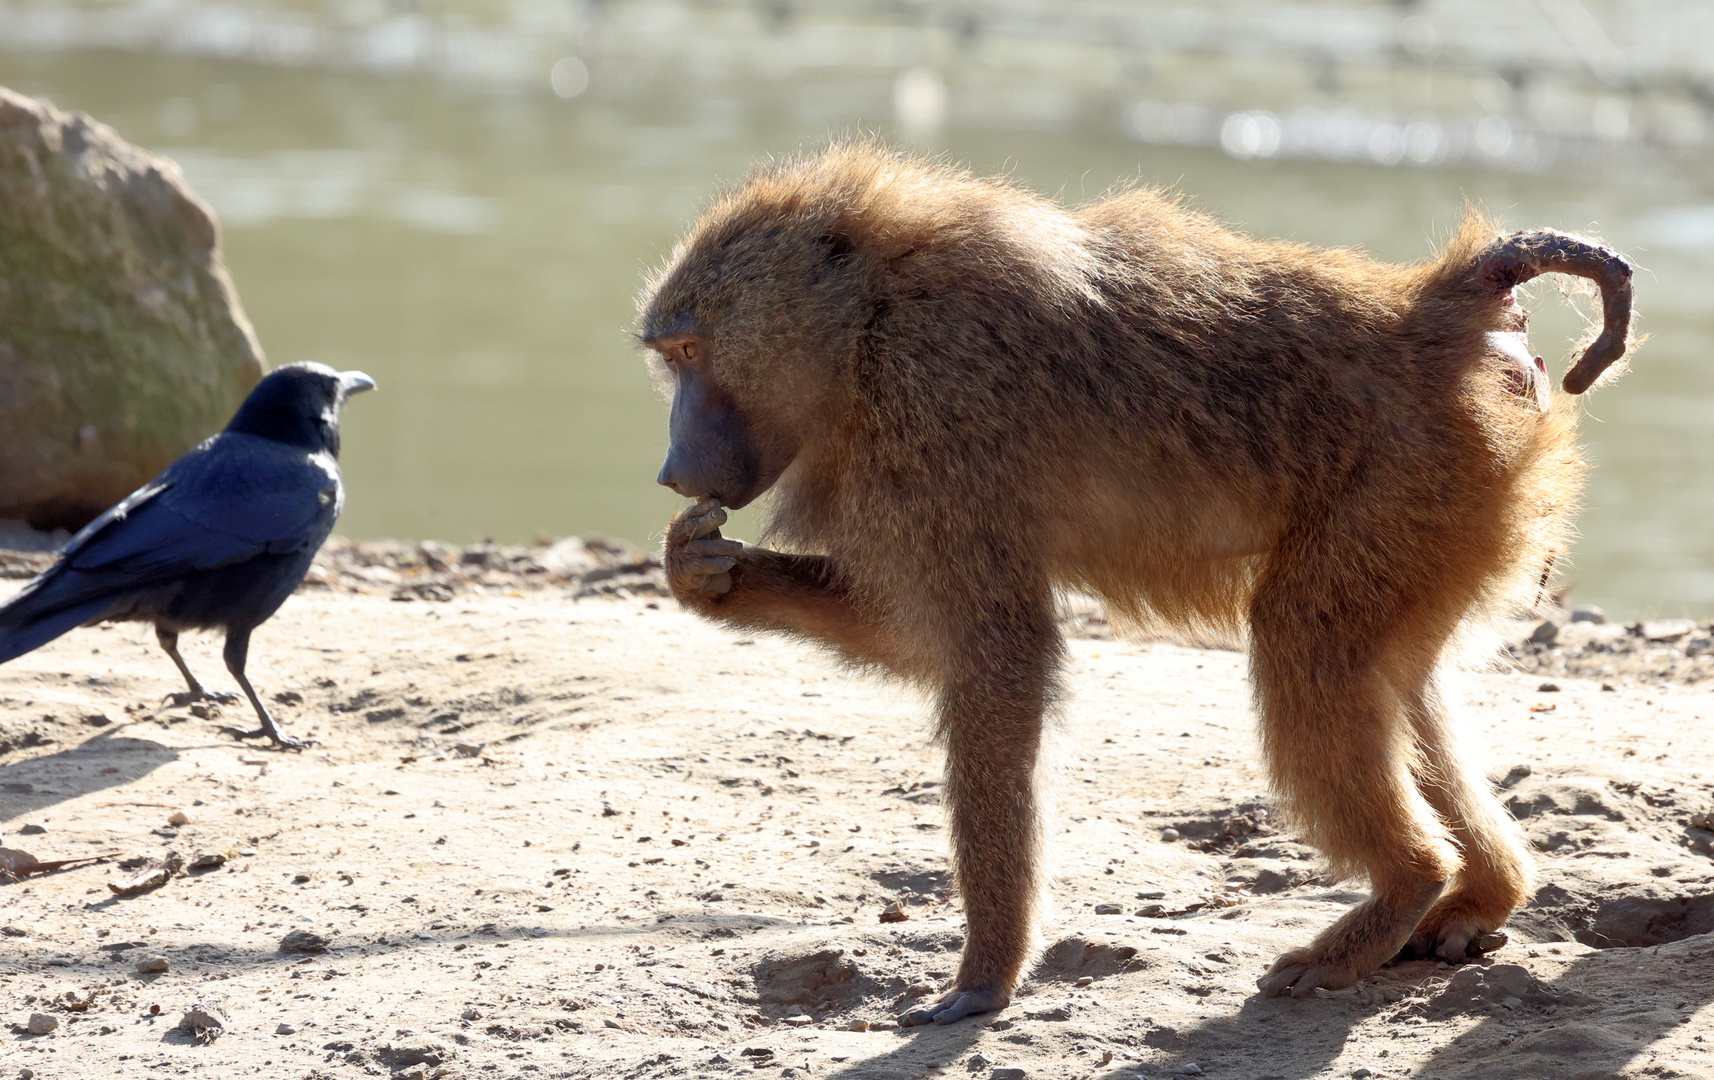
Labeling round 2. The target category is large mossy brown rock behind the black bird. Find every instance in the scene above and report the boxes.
[0,87,262,528]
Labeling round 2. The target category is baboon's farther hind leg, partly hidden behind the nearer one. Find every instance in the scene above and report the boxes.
[1404,681,1531,963]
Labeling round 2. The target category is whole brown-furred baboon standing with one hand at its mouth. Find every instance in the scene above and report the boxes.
[639,144,1630,1023]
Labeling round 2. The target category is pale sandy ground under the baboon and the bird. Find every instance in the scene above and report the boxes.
[0,581,1714,1080]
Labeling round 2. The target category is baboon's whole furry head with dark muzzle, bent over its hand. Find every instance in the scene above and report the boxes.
[638,151,925,507]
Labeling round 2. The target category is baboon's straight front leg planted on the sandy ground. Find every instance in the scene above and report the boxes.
[898,624,1059,1027]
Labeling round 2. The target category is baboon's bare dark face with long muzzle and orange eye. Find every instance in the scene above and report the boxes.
[648,331,797,509]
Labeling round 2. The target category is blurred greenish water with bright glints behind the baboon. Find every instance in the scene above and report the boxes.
[0,0,1714,615]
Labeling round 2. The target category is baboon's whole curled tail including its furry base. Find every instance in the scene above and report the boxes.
[1435,216,1632,394]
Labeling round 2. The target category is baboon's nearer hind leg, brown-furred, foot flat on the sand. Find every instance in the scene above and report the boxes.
[1251,552,1457,998]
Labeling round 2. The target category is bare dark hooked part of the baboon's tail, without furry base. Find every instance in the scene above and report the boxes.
[1476,228,1632,394]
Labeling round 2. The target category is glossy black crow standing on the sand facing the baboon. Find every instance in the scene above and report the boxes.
[0,363,375,749]
